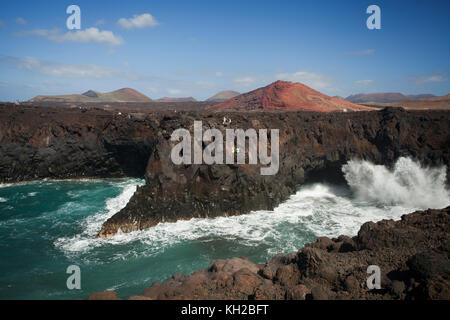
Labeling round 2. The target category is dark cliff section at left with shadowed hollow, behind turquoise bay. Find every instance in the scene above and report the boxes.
[0,105,158,182]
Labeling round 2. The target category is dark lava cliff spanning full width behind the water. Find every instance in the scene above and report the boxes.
[0,105,450,237]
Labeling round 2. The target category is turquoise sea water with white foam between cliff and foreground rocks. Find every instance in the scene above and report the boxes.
[0,158,450,299]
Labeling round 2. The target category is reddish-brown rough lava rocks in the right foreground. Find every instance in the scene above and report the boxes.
[89,207,450,300]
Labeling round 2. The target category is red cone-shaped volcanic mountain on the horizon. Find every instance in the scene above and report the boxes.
[212,81,375,112]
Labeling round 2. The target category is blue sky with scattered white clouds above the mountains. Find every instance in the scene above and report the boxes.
[0,0,450,101]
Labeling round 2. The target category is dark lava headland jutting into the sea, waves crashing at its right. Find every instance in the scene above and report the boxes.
[99,109,450,237]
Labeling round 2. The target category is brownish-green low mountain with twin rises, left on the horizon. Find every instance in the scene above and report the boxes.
[29,88,152,103]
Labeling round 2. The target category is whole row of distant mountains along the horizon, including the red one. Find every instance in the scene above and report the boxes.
[29,87,450,112]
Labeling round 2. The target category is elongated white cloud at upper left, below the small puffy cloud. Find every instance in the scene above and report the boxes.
[14,28,124,46]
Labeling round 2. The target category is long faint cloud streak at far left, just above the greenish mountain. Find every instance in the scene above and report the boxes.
[0,57,141,80]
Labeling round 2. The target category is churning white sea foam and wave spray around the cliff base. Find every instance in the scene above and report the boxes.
[56,158,450,260]
